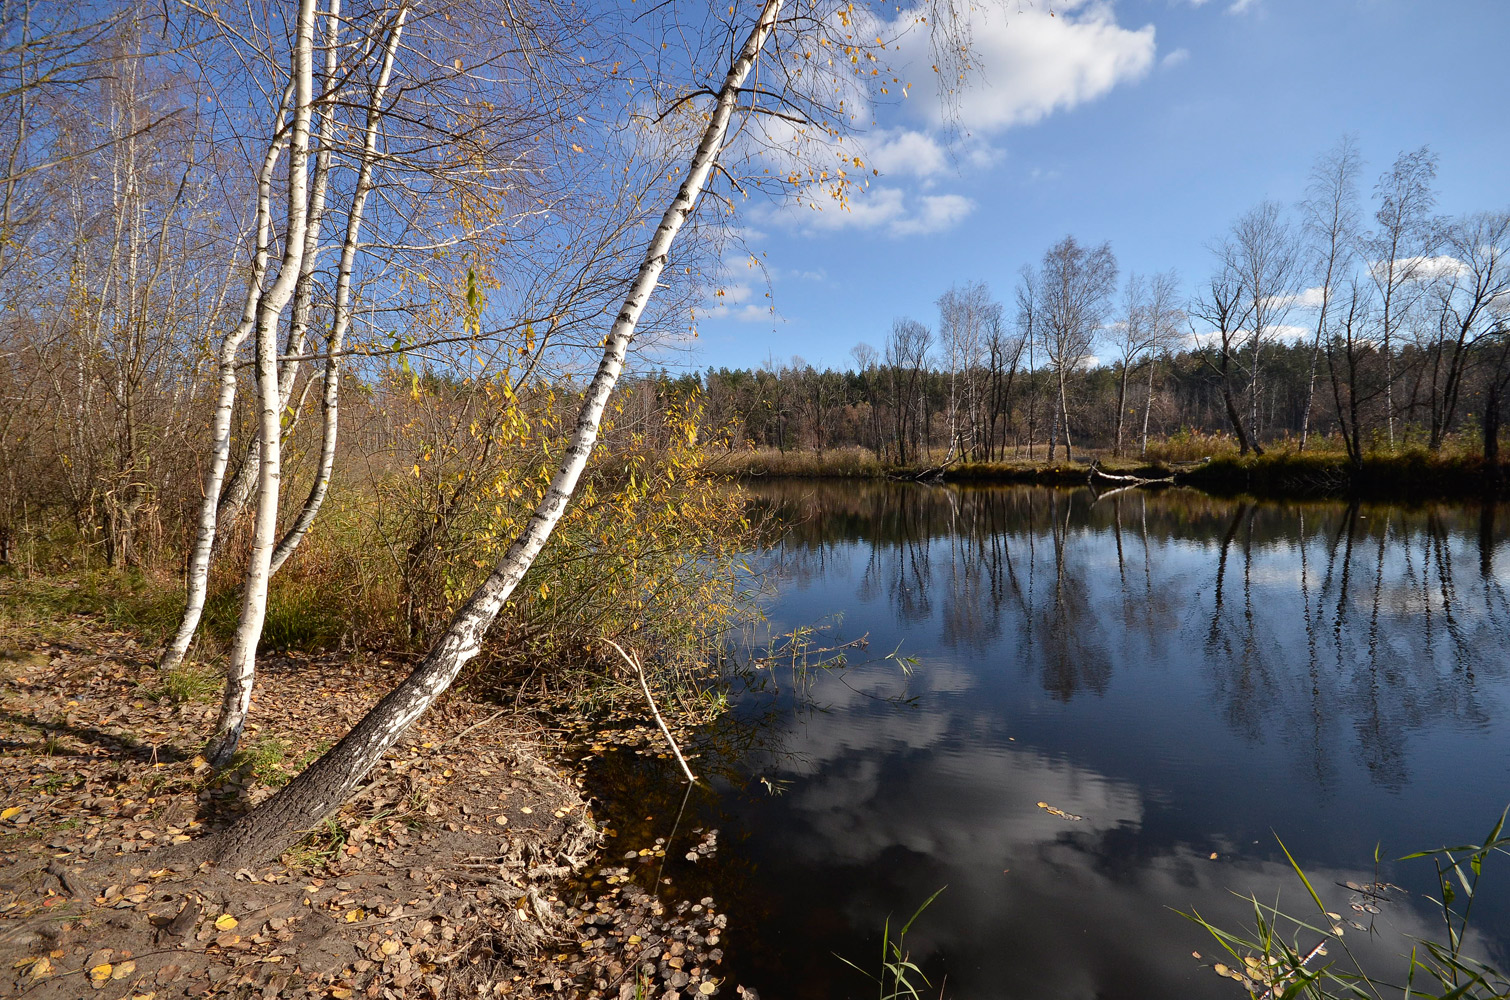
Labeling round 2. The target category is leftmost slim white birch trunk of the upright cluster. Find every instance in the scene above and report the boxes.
[157,91,291,671]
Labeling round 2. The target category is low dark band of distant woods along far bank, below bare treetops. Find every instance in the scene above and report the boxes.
[661,330,1507,464]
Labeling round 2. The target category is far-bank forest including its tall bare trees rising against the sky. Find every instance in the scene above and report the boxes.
[683,145,1510,465]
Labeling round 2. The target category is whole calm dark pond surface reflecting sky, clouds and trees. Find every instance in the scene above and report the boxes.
[582,483,1510,1000]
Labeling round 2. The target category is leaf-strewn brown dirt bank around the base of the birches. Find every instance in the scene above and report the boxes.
[0,598,743,1000]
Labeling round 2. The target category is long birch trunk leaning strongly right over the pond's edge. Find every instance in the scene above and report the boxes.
[210,0,782,867]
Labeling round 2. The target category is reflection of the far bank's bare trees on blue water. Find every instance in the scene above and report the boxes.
[742,483,1510,785]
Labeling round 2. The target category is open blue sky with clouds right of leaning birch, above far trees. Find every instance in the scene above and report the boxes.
[660,0,1510,369]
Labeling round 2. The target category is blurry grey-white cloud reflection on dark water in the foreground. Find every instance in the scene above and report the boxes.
[748,683,1486,1000]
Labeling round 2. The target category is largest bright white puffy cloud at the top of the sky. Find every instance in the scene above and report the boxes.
[901,0,1155,131]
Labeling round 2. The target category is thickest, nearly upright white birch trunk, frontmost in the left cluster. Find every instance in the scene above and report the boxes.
[204,0,314,767]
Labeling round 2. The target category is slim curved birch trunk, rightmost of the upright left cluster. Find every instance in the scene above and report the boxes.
[269,8,409,573]
